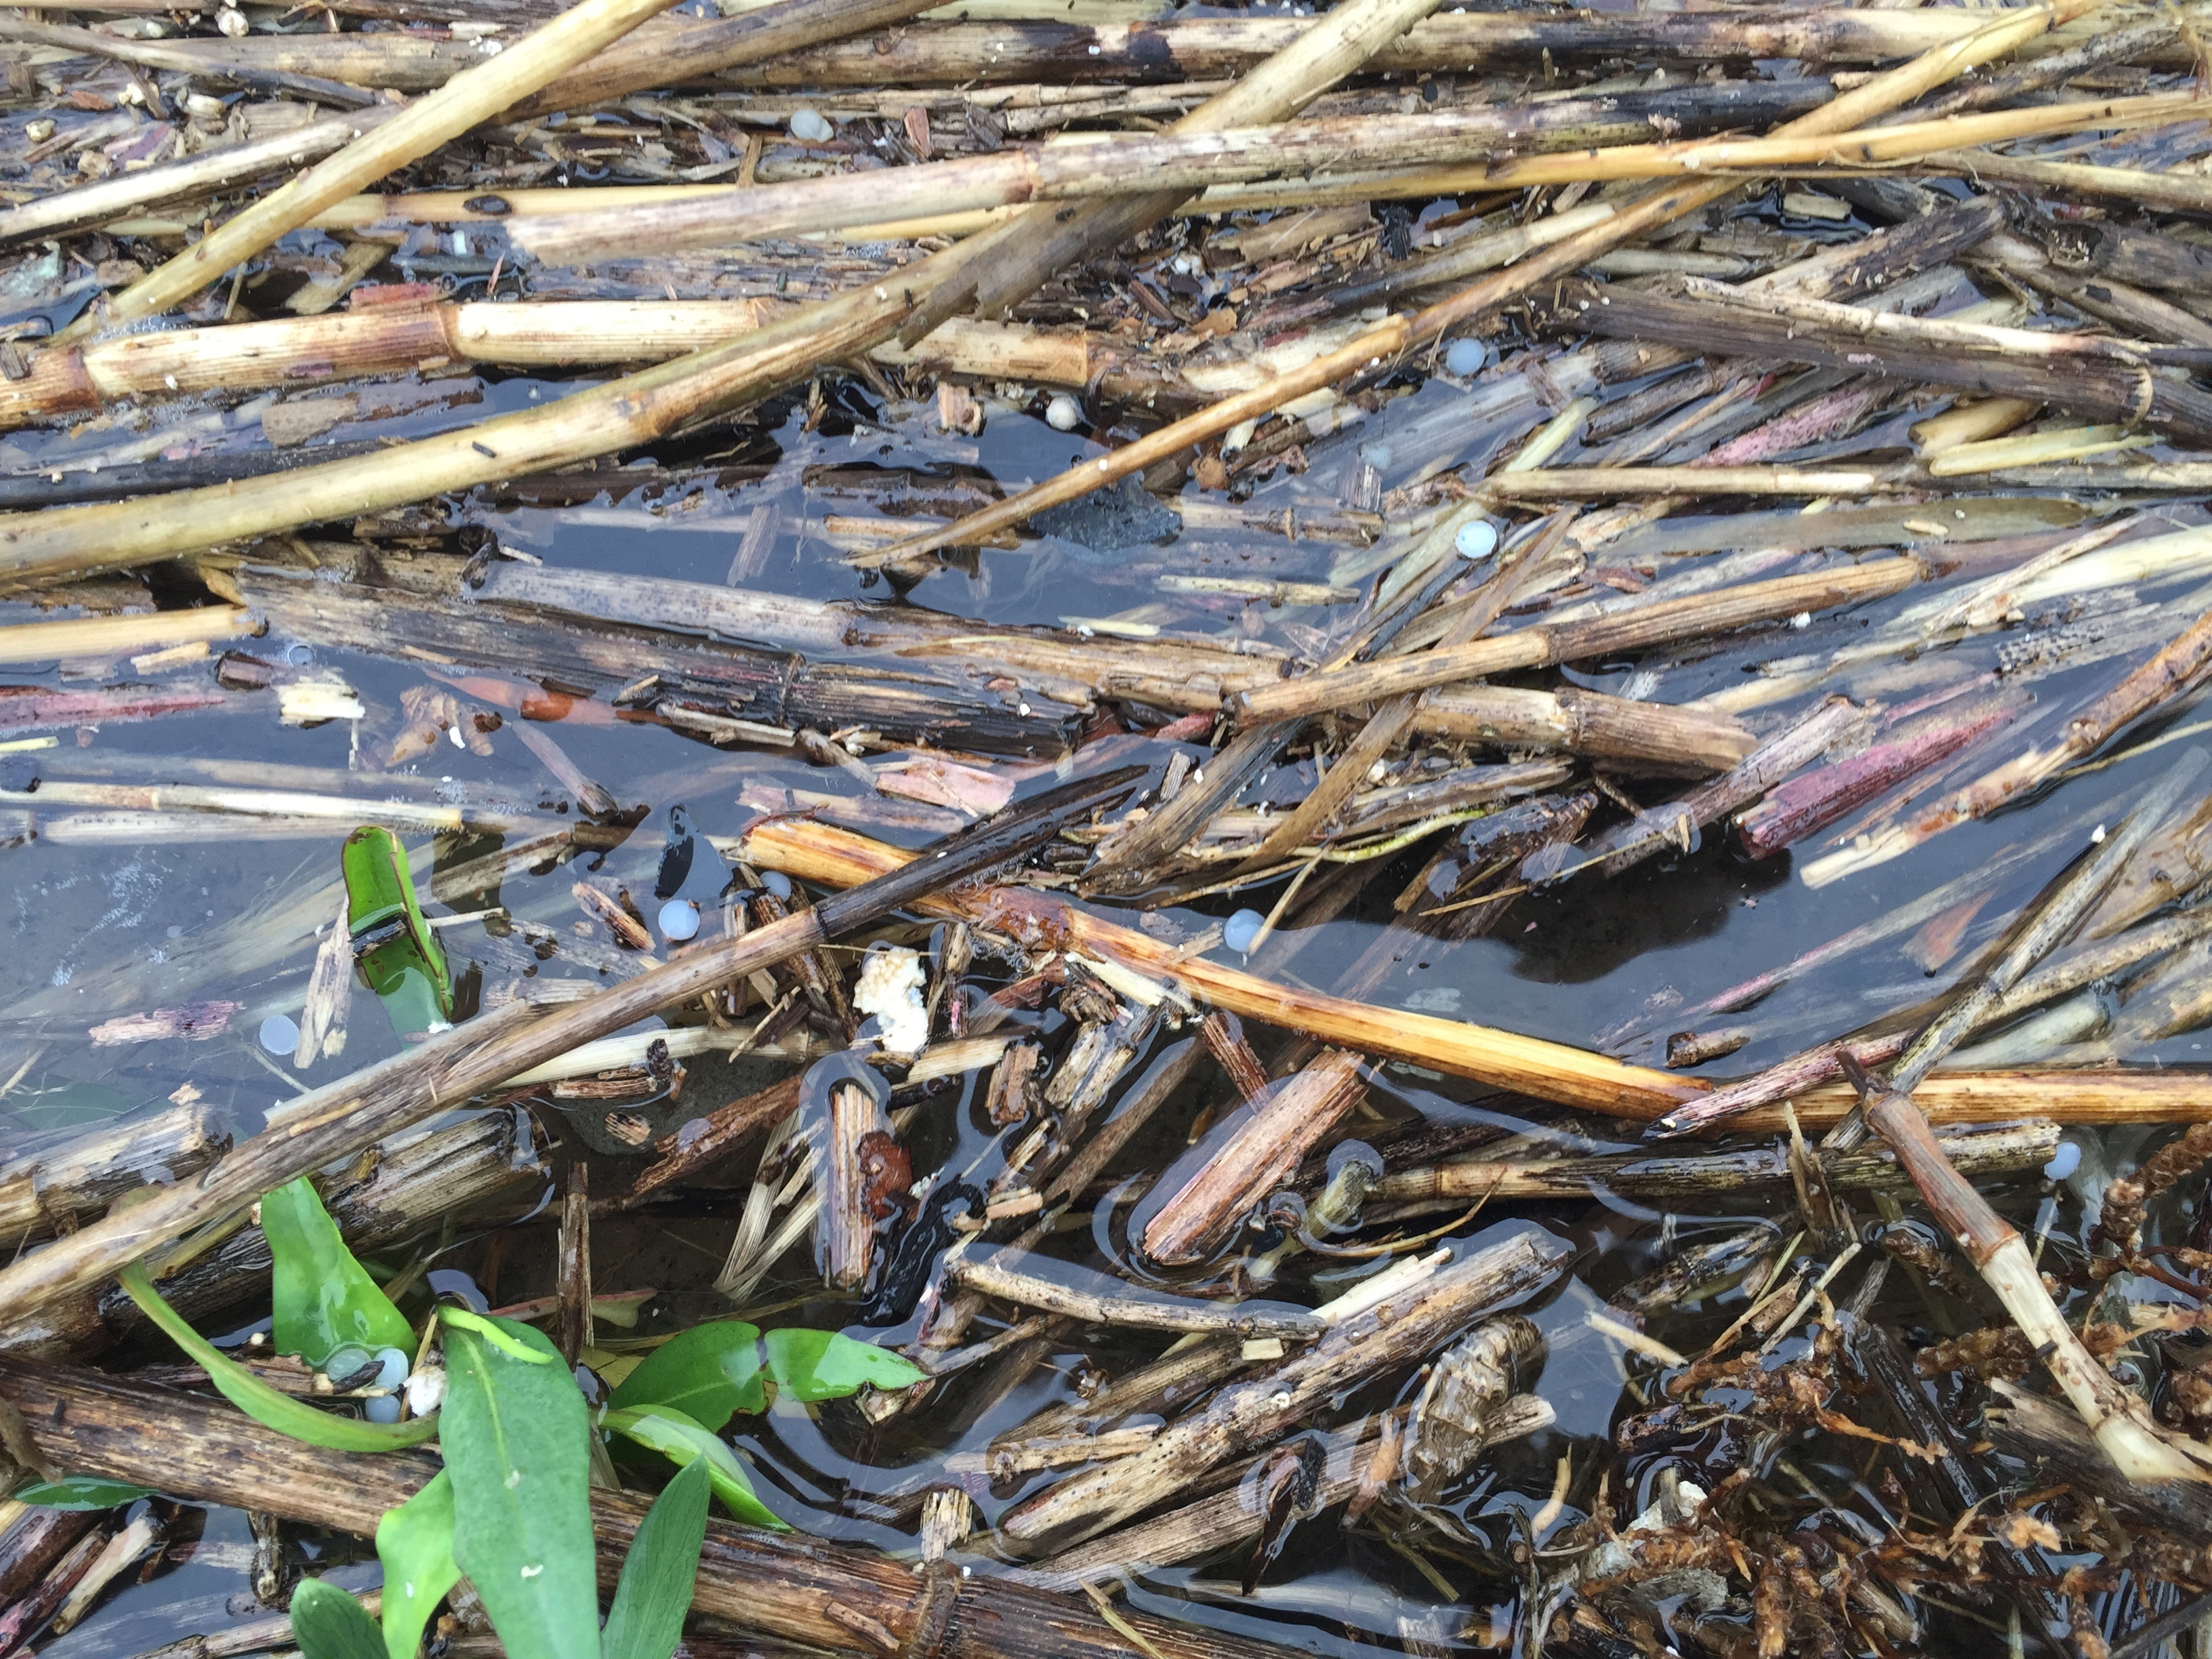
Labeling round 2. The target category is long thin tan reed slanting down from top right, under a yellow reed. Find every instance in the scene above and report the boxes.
[858,0,2100,560]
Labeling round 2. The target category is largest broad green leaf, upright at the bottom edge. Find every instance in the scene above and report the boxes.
[438,1316,600,1659]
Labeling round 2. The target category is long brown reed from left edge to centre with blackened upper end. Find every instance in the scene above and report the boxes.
[0,768,1143,1332]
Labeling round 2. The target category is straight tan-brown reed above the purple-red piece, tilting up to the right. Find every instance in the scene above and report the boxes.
[1234,558,1927,721]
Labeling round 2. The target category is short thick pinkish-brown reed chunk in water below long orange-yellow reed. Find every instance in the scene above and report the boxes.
[1141,1048,1367,1267]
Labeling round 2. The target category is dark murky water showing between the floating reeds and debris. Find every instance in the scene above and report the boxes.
[0,363,2201,1659]
